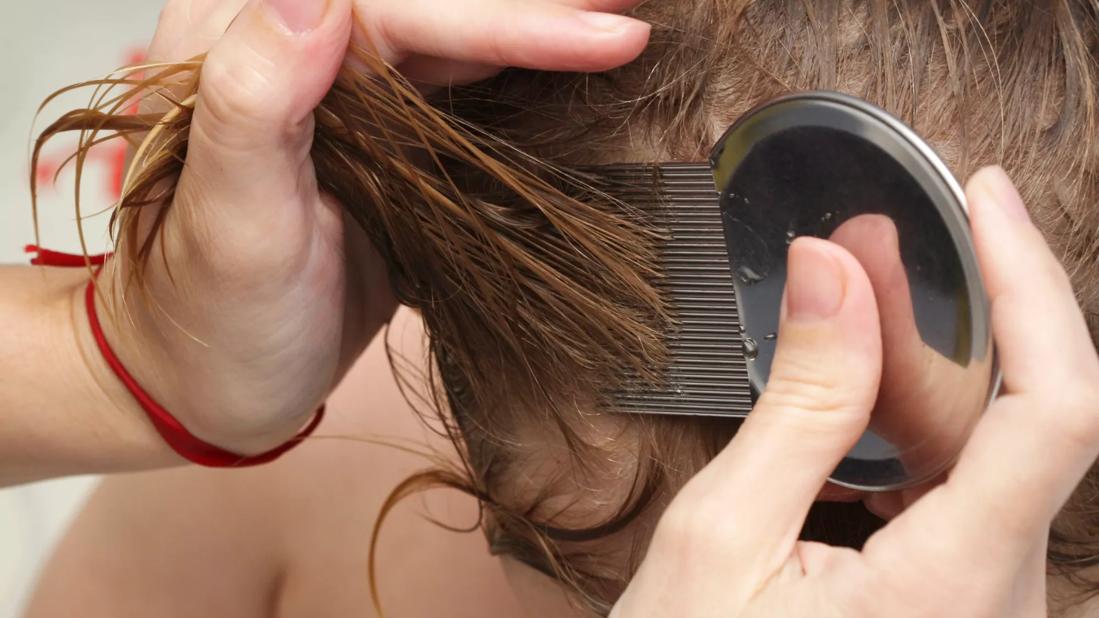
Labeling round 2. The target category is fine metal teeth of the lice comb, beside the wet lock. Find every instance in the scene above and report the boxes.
[599,164,752,417]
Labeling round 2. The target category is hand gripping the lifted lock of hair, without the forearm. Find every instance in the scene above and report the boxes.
[96,0,648,453]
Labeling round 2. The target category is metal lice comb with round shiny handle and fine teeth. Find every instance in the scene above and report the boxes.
[592,92,1000,490]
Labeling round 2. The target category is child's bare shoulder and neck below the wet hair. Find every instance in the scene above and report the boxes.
[27,314,522,618]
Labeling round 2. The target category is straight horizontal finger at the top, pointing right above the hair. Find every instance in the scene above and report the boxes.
[357,0,651,71]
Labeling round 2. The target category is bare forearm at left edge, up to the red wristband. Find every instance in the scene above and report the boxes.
[0,266,181,486]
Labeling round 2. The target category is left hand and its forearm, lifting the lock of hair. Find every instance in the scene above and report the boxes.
[0,0,650,486]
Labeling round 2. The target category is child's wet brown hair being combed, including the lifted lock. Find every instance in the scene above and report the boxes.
[32,0,1099,611]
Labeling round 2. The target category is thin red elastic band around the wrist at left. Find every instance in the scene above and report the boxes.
[26,245,324,467]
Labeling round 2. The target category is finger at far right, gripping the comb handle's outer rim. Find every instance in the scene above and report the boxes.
[943,168,1099,558]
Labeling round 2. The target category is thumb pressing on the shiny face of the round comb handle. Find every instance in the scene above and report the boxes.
[735,238,881,533]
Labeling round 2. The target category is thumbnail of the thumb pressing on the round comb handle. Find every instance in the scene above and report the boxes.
[786,238,847,320]
